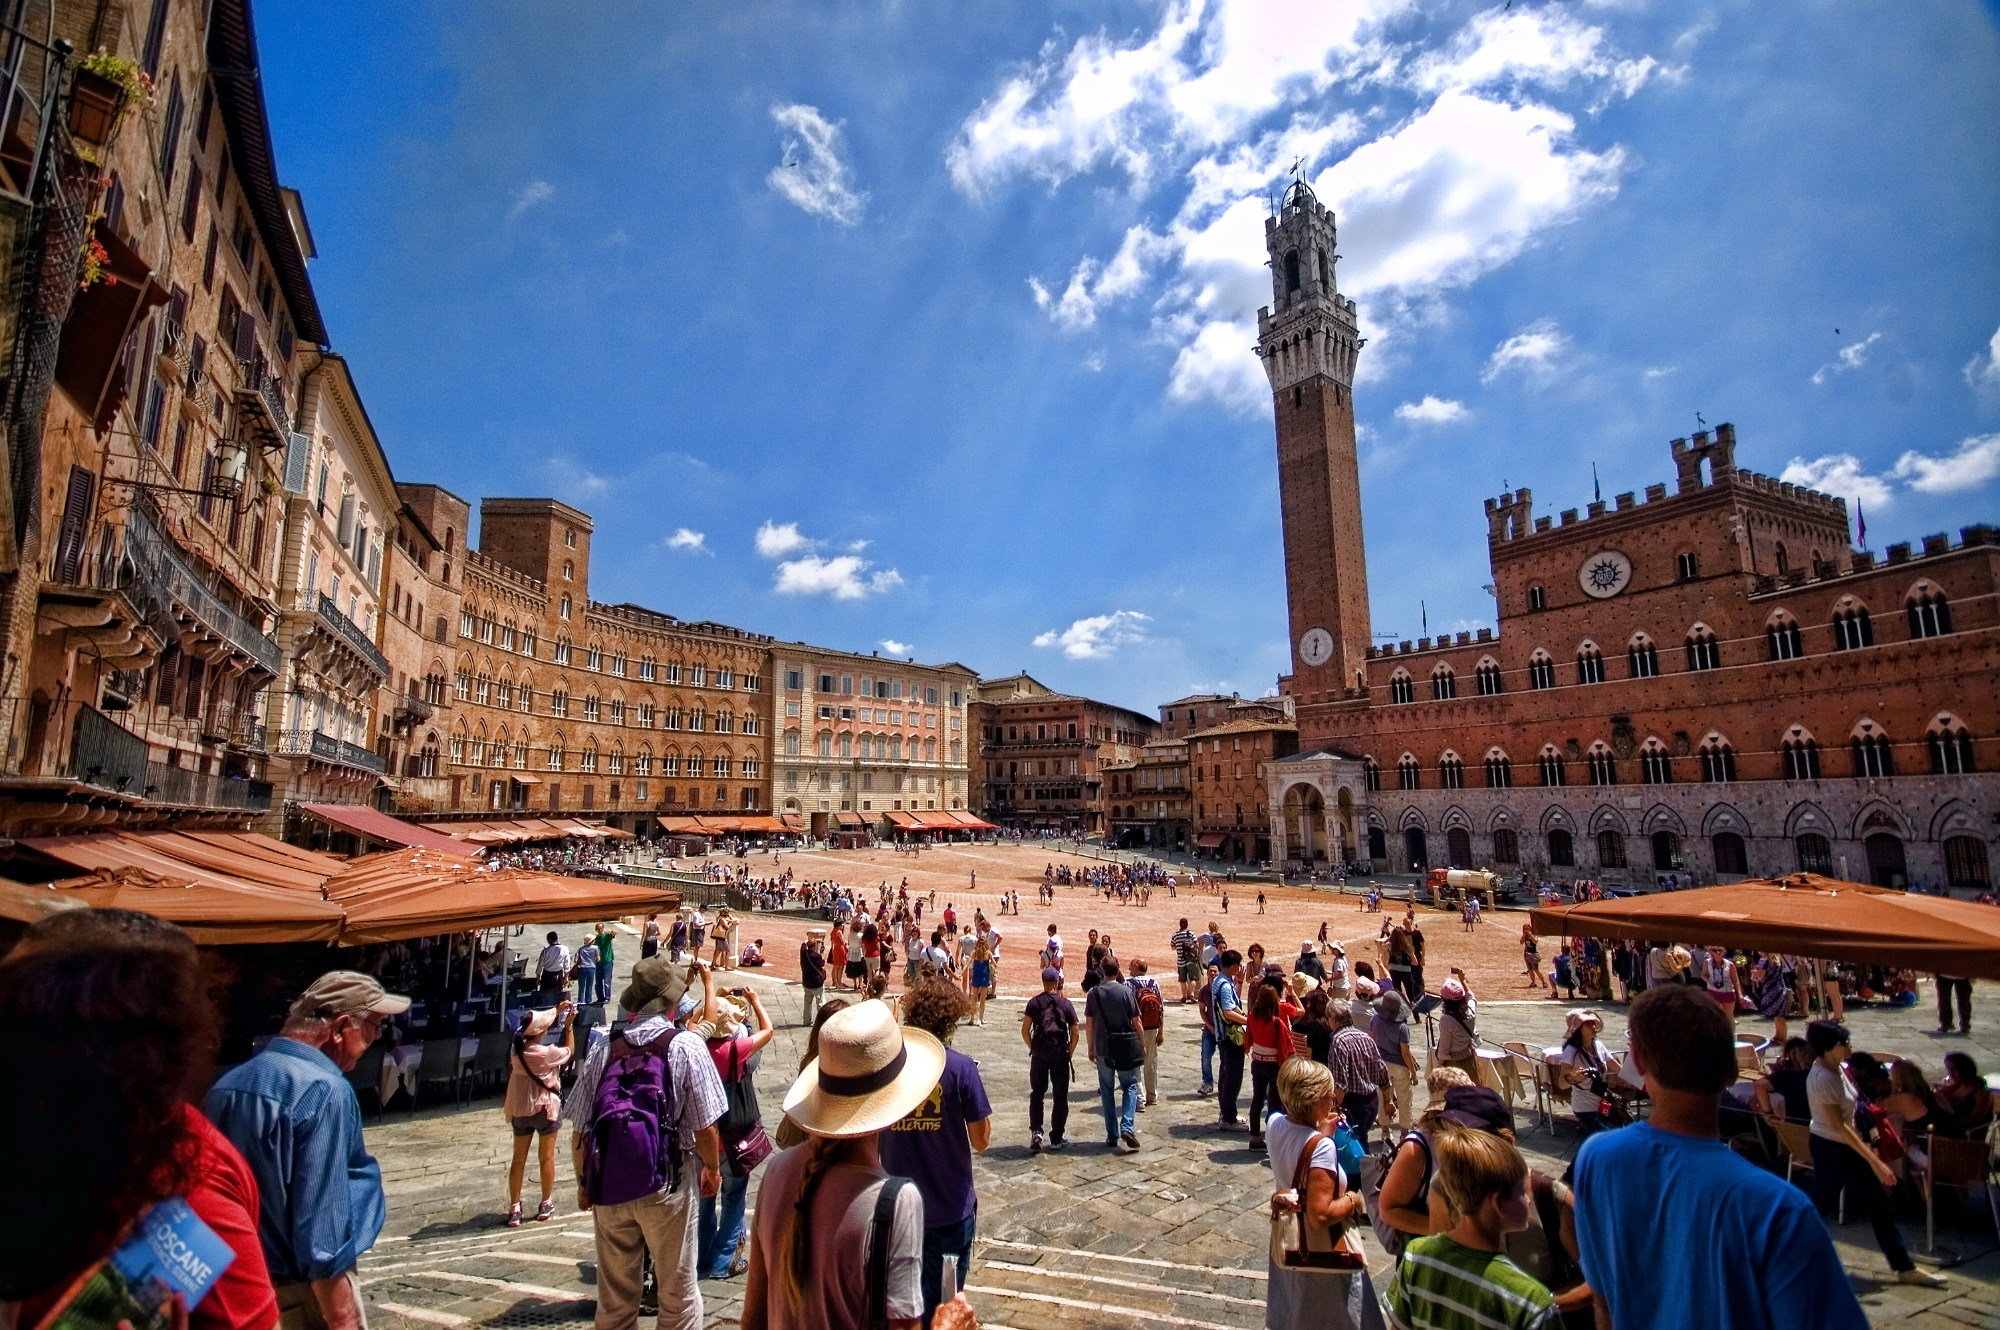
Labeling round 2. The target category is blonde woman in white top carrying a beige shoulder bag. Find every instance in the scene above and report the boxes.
[1264,1058,1382,1330]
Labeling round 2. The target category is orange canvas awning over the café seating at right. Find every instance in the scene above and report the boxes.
[1528,874,2000,978]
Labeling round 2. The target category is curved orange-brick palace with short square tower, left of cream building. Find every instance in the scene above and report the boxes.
[446,498,772,834]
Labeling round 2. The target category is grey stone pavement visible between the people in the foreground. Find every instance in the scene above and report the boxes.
[360,902,2000,1330]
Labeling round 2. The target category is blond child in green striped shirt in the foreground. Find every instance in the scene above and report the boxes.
[1388,1126,1560,1330]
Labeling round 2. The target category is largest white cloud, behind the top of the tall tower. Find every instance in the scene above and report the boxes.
[946,0,1640,410]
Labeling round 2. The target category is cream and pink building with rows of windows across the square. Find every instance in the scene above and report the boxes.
[770,642,978,836]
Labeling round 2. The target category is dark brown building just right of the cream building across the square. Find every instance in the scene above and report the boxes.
[974,672,1158,836]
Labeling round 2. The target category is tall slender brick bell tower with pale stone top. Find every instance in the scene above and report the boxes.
[1256,182,1372,702]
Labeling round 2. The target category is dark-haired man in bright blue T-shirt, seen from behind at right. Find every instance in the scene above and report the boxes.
[1576,984,1868,1330]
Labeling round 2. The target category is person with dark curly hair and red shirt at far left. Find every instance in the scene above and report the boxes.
[0,910,278,1330]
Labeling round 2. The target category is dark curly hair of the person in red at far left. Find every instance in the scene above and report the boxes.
[0,920,216,1298]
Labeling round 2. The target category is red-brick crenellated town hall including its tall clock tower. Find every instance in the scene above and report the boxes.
[1256,186,2000,890]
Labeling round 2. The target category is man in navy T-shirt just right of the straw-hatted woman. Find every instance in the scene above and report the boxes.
[880,980,994,1318]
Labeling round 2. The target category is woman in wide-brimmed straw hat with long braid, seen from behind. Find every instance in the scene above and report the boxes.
[742,1002,978,1330]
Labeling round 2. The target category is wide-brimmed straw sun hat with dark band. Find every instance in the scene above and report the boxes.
[784,1002,944,1138]
